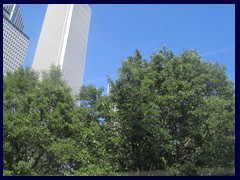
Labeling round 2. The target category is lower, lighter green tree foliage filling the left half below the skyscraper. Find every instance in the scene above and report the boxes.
[3,67,117,175]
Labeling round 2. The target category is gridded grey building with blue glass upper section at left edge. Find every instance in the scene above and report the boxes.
[3,4,29,75]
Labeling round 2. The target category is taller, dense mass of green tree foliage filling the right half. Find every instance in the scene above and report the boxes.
[110,47,235,175]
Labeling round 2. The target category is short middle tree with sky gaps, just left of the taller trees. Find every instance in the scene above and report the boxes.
[74,85,120,175]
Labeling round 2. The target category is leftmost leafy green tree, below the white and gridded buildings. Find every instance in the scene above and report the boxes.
[3,67,74,175]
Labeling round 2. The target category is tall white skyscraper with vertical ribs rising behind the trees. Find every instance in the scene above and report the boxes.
[32,4,91,94]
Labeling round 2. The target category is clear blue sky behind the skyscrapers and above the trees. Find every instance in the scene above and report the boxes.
[21,4,235,94]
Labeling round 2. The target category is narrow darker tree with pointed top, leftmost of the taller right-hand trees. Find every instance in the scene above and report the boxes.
[111,50,172,171]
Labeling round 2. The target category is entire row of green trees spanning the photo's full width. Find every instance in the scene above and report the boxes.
[3,46,235,175]
